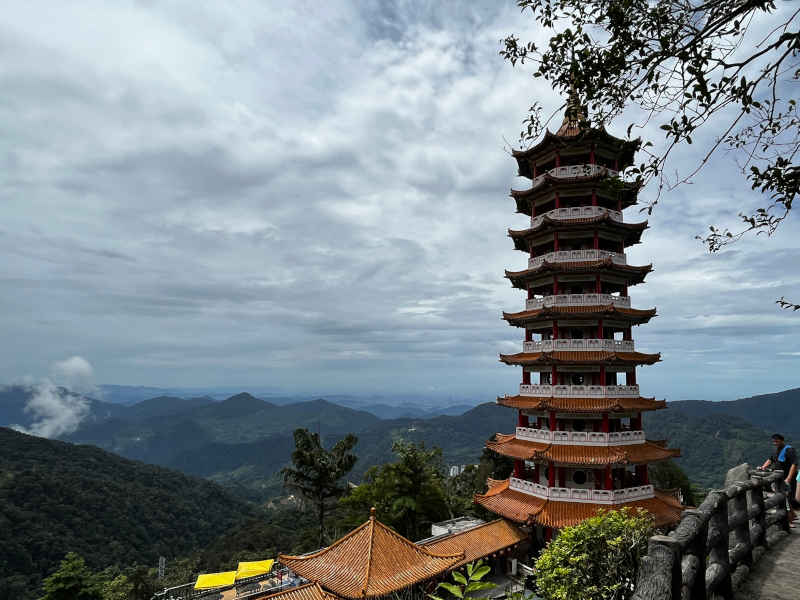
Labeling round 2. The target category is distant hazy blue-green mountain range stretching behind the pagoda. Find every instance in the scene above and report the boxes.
[0,387,800,500]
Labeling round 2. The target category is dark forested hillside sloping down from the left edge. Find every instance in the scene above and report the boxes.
[0,428,254,600]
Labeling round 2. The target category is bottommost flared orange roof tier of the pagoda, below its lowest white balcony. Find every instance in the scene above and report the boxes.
[475,478,683,530]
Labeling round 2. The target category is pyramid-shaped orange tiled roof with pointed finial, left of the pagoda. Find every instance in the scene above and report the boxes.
[278,515,464,599]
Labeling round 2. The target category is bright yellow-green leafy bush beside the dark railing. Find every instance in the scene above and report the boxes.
[536,508,653,600]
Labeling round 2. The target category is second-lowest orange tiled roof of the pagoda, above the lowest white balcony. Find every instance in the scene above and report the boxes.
[486,433,680,465]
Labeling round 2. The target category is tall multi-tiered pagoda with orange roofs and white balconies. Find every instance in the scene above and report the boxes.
[476,102,682,540]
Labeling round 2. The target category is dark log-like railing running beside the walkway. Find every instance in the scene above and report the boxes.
[633,467,789,600]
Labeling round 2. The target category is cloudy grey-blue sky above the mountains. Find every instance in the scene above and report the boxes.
[0,1,800,400]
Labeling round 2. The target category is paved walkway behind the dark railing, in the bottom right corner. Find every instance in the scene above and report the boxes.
[736,523,800,600]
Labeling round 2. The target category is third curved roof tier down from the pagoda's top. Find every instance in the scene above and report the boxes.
[508,216,647,252]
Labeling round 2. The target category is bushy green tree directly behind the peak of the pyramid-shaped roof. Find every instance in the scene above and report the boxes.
[341,441,450,540]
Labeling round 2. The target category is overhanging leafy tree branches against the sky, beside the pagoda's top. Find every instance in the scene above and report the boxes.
[500,0,800,310]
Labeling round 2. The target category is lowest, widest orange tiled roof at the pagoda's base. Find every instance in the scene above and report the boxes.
[475,480,683,529]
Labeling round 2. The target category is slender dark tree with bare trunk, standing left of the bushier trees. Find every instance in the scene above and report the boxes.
[281,429,358,547]
